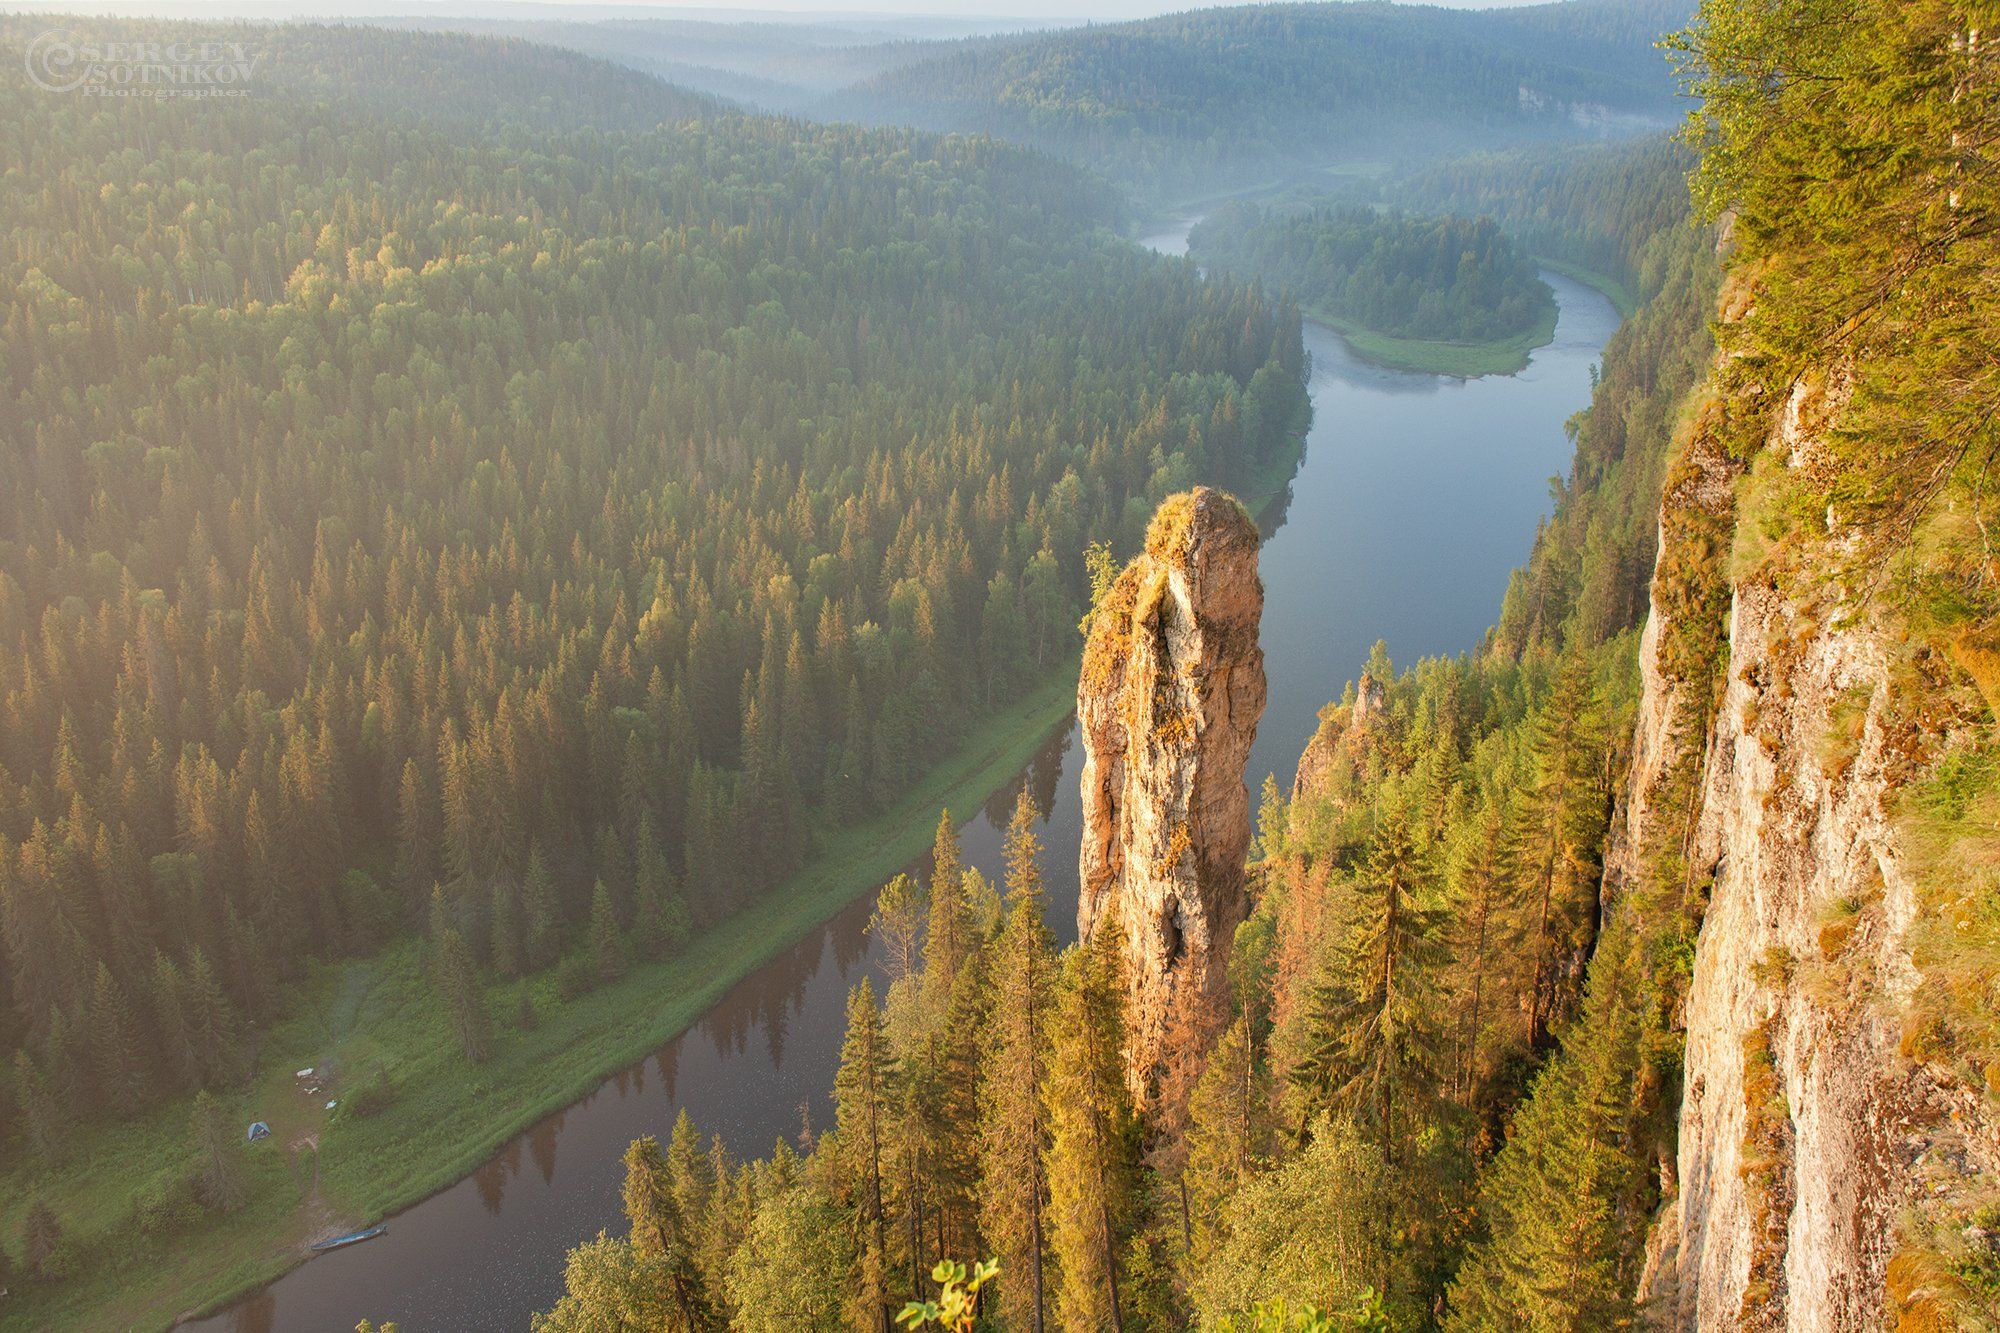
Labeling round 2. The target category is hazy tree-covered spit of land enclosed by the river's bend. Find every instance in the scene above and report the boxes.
[1188,202,1556,376]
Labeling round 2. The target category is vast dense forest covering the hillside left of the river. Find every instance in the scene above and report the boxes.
[0,22,1304,1184]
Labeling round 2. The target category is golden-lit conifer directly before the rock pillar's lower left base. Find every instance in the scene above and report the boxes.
[1042,929,1140,1333]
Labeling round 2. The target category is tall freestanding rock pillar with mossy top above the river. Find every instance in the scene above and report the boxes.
[1076,486,1264,1099]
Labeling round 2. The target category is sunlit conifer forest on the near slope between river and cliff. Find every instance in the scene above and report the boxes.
[538,111,1716,1331]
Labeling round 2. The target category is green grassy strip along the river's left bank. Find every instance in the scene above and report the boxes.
[0,428,1304,1331]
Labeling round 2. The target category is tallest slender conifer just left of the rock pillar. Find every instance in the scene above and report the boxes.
[980,789,1054,1333]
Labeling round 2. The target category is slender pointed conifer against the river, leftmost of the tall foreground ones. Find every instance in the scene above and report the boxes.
[834,977,894,1333]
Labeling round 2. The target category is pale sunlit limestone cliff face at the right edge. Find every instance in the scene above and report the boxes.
[1608,378,2000,1333]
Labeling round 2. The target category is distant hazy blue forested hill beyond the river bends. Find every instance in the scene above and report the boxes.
[826,0,1692,196]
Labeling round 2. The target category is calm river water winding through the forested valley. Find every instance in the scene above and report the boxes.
[196,213,1618,1333]
